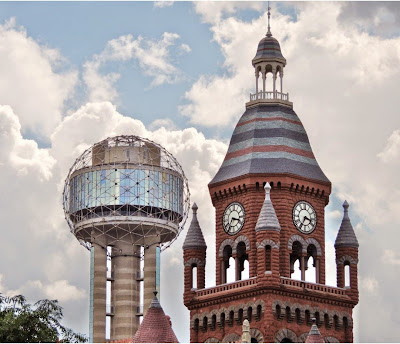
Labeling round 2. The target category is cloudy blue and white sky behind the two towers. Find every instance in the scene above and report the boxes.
[0,2,400,342]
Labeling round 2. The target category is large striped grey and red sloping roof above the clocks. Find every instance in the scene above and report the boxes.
[210,103,330,185]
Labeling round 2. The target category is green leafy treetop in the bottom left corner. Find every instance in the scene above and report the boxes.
[0,294,87,343]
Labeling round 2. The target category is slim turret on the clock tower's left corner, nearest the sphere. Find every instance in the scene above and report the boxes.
[182,203,207,304]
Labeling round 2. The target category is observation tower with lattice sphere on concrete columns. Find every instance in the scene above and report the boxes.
[63,136,189,342]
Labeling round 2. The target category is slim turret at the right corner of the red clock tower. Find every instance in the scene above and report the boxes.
[335,201,359,302]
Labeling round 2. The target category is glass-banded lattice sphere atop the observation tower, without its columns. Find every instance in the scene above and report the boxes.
[63,136,189,248]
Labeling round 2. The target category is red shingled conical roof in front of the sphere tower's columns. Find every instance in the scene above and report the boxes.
[133,293,179,343]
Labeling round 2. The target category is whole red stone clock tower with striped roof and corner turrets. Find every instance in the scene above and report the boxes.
[183,10,358,342]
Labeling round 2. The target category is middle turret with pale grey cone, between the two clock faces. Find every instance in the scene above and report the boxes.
[255,183,281,283]
